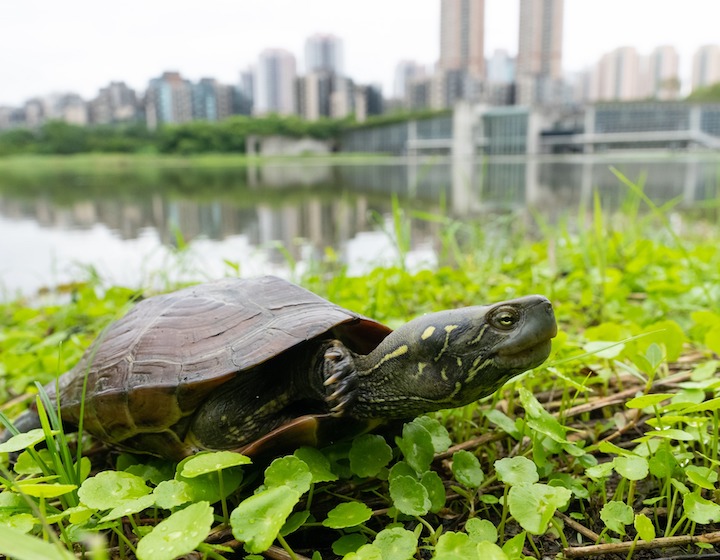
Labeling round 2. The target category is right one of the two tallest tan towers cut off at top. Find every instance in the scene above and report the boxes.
[517,0,564,105]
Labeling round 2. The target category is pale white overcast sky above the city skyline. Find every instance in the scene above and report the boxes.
[0,0,720,105]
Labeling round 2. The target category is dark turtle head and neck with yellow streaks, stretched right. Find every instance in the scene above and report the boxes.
[352,296,557,418]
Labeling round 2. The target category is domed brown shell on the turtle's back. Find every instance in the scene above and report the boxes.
[54,276,390,442]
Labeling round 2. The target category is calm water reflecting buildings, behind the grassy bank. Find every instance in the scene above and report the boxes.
[0,154,720,297]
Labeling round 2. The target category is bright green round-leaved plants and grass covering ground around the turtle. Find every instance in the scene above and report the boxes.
[0,174,720,560]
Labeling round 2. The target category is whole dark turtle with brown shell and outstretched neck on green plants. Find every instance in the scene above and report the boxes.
[5,276,557,461]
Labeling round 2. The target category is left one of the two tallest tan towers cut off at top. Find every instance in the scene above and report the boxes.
[438,0,485,80]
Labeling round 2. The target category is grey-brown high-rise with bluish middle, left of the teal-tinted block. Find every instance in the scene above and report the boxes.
[145,72,193,129]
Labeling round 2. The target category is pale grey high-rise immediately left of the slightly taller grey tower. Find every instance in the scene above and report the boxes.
[253,49,295,115]
